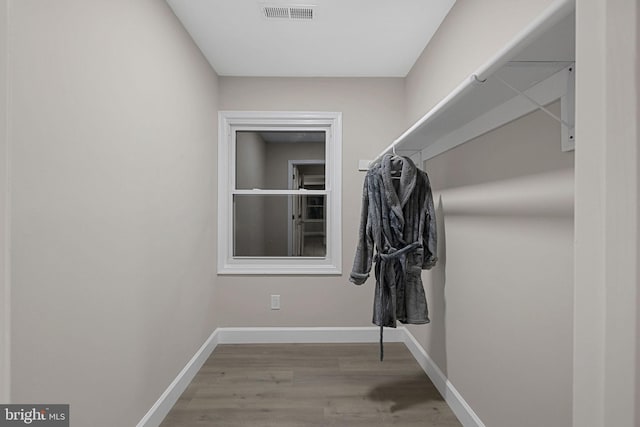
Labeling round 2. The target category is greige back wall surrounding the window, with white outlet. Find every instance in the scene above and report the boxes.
[215,77,404,326]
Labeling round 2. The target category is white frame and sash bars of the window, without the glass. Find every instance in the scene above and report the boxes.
[218,111,342,274]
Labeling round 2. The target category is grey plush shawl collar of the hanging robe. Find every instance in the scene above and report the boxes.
[381,154,418,219]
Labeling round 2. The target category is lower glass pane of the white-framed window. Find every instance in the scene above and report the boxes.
[233,194,327,257]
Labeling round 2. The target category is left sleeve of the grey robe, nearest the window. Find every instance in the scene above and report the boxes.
[349,171,374,285]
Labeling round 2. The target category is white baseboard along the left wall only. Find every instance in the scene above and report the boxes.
[137,329,218,427]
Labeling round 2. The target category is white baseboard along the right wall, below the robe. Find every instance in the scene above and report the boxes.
[403,328,485,427]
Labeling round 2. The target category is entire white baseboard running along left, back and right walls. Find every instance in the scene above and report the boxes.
[137,326,485,427]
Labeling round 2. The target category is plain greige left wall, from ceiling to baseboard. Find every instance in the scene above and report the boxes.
[9,0,218,427]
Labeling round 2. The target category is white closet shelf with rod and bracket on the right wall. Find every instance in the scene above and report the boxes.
[374,0,575,166]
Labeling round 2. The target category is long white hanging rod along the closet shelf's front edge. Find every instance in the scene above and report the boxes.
[371,0,575,164]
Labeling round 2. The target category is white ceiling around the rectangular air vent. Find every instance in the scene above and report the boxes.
[166,0,455,77]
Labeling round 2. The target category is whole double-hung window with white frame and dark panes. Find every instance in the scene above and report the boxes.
[218,111,342,274]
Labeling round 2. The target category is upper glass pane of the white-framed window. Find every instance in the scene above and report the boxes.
[236,131,326,190]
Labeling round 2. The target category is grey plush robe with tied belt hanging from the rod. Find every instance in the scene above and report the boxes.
[349,154,437,334]
